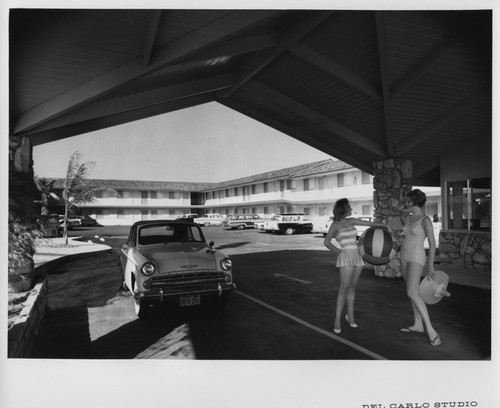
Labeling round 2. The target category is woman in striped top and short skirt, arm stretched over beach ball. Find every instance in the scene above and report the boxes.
[324,198,390,334]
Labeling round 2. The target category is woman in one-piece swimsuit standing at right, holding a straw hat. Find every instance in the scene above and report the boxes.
[400,190,441,346]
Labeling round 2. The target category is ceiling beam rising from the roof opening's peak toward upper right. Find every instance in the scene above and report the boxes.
[221,11,332,98]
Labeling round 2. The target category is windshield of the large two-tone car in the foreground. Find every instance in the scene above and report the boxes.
[139,224,204,245]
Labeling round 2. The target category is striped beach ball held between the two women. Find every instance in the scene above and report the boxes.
[358,227,398,265]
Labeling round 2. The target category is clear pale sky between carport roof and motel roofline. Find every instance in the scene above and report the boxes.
[33,102,332,182]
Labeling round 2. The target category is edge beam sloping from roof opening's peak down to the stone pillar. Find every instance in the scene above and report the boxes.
[218,98,373,174]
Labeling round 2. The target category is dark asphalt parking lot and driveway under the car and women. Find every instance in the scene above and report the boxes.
[33,227,491,360]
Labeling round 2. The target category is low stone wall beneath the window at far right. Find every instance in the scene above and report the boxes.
[439,231,491,271]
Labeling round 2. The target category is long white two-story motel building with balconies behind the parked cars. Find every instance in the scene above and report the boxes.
[50,159,441,225]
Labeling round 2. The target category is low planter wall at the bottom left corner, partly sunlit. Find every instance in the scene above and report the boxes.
[8,276,48,358]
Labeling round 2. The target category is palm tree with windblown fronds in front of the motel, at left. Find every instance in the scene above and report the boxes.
[62,151,117,245]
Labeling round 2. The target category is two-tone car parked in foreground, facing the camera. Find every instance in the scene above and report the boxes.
[120,220,236,318]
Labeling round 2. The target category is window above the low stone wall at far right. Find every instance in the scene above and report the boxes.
[446,177,491,231]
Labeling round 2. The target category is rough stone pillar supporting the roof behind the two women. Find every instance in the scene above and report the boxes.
[373,159,412,278]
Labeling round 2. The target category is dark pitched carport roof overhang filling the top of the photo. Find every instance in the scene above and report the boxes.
[10,9,492,185]
